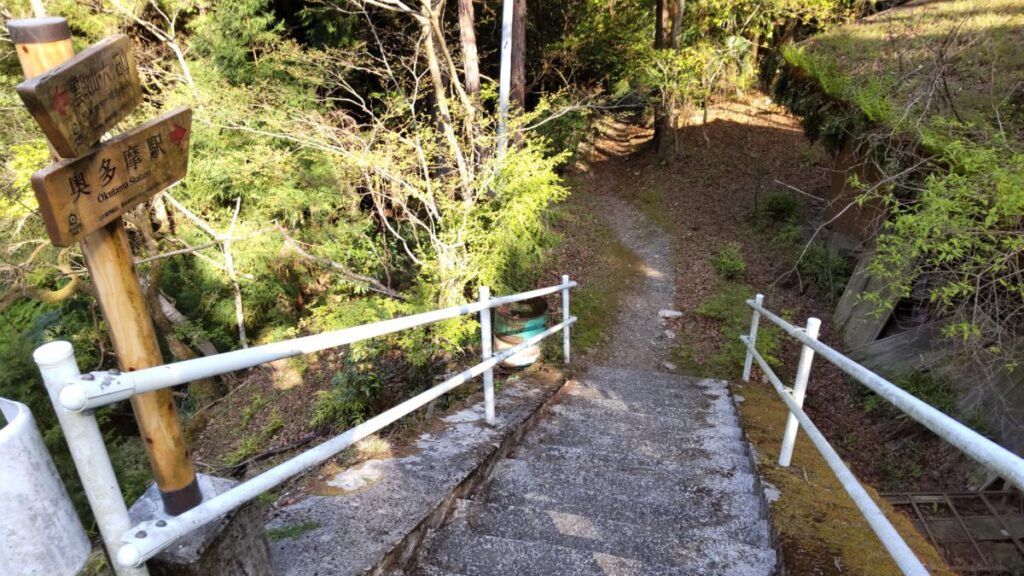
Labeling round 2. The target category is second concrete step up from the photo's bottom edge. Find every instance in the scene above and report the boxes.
[452,500,775,574]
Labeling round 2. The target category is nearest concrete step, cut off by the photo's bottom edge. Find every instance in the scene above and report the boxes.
[430,526,720,576]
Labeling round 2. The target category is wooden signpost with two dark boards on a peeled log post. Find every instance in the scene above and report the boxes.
[7,17,203,515]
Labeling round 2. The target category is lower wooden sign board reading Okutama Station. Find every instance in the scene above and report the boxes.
[32,108,191,247]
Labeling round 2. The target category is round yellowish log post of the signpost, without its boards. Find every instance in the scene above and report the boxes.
[7,17,203,515]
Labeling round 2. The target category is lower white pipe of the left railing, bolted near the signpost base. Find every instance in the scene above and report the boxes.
[117,313,577,566]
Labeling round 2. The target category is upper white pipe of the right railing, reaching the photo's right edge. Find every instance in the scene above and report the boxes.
[746,300,1024,490]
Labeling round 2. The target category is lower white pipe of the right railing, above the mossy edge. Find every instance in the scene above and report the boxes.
[739,336,928,576]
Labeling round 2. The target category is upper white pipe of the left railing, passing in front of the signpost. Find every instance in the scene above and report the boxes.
[60,282,577,411]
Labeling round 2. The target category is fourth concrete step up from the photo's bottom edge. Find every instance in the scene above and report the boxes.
[493,448,755,498]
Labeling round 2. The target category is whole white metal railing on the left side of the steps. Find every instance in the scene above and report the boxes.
[34,276,577,576]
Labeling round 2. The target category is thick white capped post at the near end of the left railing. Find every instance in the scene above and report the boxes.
[32,340,150,576]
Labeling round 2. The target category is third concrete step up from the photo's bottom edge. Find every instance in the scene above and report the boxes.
[481,455,761,532]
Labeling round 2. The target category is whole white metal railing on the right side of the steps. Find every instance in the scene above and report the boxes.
[739,294,1024,576]
